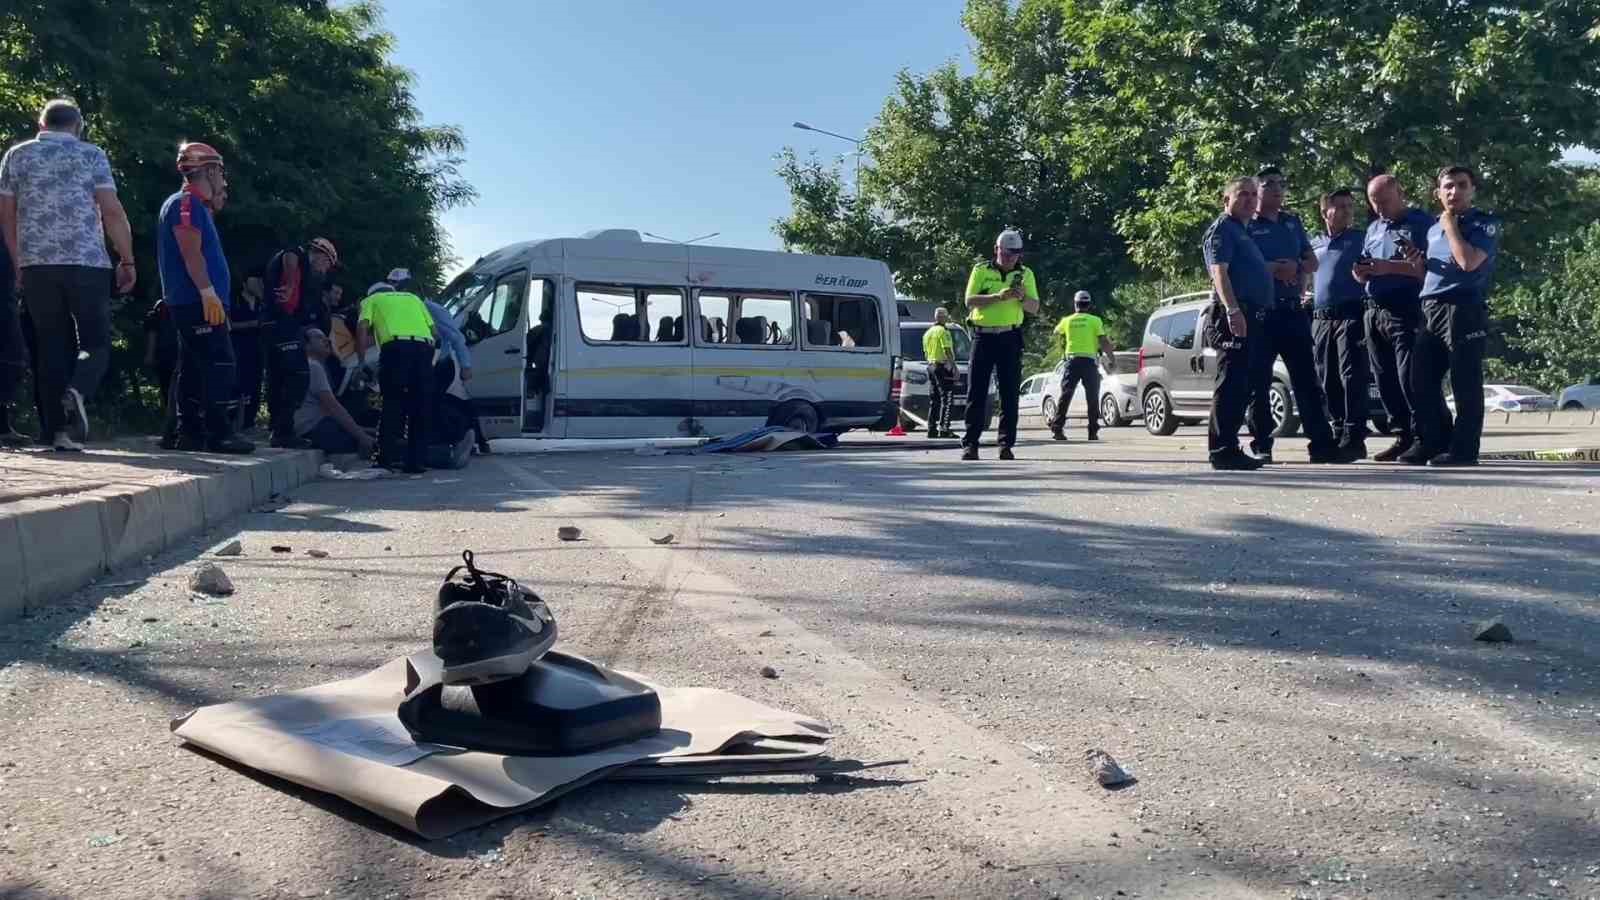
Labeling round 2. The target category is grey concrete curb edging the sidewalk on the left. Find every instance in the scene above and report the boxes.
[0,450,322,623]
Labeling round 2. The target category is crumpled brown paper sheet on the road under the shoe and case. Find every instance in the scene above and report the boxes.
[171,658,832,838]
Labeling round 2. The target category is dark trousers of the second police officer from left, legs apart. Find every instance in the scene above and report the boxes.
[1248,304,1336,453]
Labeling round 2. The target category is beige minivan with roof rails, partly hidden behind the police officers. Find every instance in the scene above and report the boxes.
[1136,291,1389,437]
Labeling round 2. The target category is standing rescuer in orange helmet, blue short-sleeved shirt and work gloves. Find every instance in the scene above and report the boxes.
[155,143,256,453]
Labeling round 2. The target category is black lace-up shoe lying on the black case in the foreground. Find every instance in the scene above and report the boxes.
[434,551,555,684]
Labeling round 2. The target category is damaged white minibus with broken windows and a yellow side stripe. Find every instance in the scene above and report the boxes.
[440,229,899,439]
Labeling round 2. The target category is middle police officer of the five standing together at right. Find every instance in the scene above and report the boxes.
[1312,189,1373,460]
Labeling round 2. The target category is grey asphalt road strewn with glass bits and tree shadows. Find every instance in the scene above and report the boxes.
[0,428,1600,898]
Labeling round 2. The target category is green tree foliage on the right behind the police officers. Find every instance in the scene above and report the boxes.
[778,0,1600,377]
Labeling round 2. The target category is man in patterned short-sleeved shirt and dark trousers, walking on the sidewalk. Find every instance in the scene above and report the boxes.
[0,99,134,450]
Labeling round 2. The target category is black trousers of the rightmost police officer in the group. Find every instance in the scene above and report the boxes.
[1411,296,1490,460]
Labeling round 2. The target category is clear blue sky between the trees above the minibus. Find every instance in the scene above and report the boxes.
[384,0,970,273]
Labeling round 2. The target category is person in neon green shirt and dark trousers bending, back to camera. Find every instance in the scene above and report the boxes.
[355,282,434,474]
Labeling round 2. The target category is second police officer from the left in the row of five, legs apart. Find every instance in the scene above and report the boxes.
[1248,167,1354,463]
